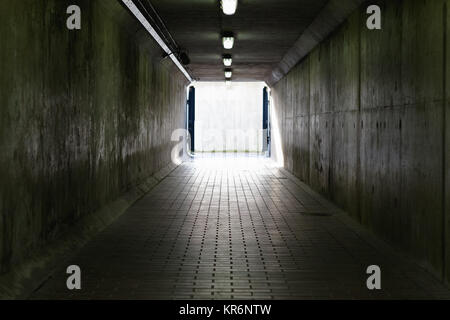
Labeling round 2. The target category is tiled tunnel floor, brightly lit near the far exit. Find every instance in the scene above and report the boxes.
[31,154,450,299]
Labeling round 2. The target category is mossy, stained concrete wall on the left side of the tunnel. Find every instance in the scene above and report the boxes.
[0,0,186,273]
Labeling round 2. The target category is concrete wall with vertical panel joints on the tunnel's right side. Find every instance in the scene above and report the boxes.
[272,0,450,280]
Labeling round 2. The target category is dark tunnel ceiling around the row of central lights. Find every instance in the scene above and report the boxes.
[146,0,328,81]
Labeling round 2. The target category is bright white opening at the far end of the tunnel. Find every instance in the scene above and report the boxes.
[194,82,267,153]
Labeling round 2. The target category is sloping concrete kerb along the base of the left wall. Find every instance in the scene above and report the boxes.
[0,164,177,300]
